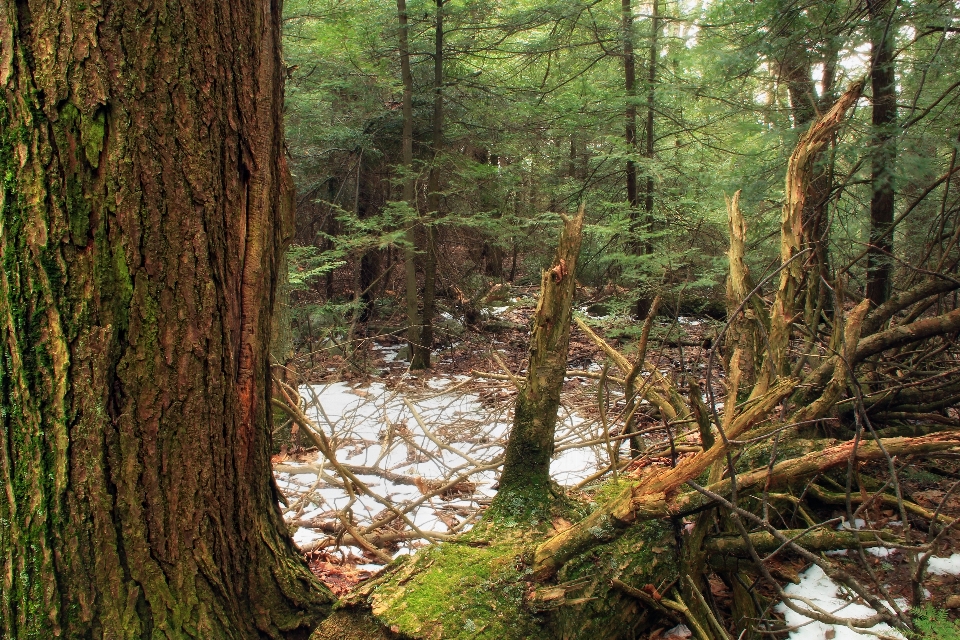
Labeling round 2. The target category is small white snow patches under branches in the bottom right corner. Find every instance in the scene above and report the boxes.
[776,552,960,640]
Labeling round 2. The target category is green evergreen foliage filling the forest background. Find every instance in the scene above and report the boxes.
[284,0,960,312]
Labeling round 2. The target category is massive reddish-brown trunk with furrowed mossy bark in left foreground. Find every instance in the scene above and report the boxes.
[0,0,332,639]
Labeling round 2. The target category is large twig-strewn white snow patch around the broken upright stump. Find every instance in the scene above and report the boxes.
[275,376,607,564]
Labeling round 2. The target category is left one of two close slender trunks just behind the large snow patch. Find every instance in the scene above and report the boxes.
[397,0,421,365]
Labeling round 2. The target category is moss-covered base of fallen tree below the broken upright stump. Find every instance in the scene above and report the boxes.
[311,488,679,640]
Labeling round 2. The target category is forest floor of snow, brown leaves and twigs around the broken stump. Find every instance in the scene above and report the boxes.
[274,287,960,640]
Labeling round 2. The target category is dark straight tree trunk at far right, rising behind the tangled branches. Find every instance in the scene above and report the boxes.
[867,0,897,305]
